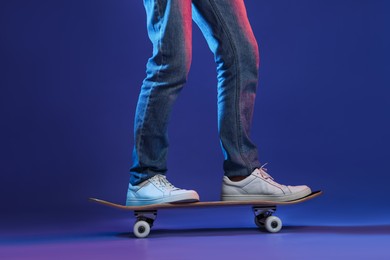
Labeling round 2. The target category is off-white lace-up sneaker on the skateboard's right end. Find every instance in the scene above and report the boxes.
[221,168,311,201]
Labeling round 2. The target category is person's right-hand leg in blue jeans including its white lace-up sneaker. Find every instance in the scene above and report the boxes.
[193,0,311,201]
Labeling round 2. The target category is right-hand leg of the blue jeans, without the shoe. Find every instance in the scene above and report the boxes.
[193,0,260,177]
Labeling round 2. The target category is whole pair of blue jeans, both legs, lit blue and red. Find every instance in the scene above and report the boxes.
[130,0,260,185]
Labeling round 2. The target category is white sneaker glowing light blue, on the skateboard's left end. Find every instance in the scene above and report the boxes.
[126,174,199,206]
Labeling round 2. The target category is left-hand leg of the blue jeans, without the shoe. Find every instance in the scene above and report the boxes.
[130,0,192,185]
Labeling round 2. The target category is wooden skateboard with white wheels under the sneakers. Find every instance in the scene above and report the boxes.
[90,191,322,238]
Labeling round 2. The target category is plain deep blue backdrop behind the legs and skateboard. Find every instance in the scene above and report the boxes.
[0,0,390,224]
